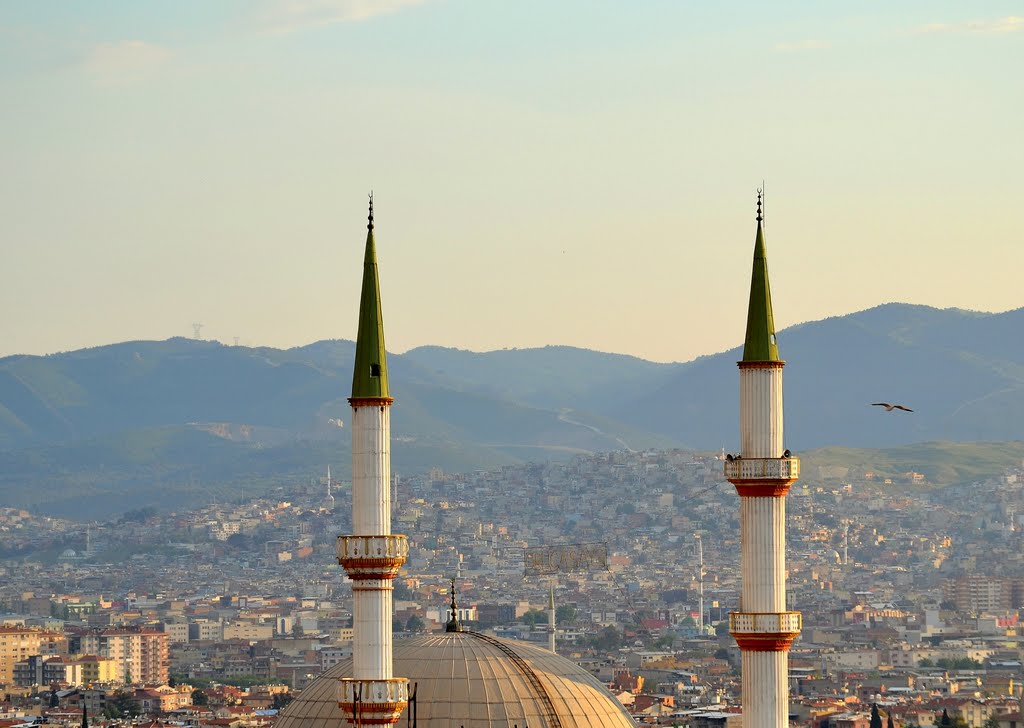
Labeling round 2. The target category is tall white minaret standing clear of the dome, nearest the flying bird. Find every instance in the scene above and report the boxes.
[725,190,801,728]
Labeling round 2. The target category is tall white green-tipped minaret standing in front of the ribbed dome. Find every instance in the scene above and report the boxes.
[338,195,409,726]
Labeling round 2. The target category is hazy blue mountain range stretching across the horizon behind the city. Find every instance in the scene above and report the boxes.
[0,304,1024,515]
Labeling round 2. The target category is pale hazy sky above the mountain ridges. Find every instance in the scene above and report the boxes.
[0,0,1024,360]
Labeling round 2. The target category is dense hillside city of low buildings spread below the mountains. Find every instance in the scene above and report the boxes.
[0,451,1024,728]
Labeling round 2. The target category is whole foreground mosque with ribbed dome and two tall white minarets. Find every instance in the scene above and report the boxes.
[276,192,801,728]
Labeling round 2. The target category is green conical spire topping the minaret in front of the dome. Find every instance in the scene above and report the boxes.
[352,194,391,399]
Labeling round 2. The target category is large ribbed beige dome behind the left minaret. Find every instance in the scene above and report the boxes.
[275,632,636,728]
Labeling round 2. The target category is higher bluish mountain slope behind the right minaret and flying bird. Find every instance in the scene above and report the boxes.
[618,304,1024,451]
